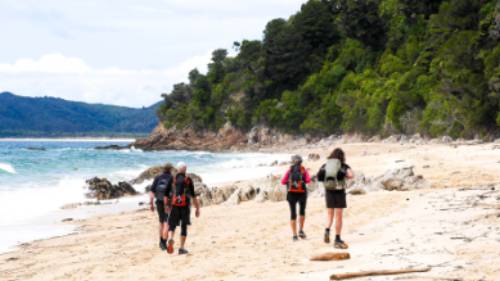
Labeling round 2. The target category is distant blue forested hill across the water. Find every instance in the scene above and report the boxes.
[0,92,159,137]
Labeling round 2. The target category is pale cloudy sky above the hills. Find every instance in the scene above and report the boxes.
[0,0,306,107]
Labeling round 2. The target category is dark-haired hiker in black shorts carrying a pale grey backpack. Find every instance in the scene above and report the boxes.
[317,148,354,249]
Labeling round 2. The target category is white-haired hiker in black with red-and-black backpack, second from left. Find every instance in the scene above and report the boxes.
[165,162,200,255]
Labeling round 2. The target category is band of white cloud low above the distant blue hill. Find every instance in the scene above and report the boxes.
[0,54,210,106]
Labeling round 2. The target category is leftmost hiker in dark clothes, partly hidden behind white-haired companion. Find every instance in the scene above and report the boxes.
[149,164,173,250]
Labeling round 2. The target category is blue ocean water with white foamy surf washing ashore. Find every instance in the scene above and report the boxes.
[0,139,289,251]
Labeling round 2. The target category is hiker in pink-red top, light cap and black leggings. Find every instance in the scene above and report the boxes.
[281,155,311,241]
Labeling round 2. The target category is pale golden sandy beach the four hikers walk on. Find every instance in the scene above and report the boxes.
[0,143,500,280]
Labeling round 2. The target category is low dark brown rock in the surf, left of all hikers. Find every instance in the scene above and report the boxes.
[85,177,137,200]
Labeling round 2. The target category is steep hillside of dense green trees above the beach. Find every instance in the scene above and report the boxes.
[160,0,500,137]
